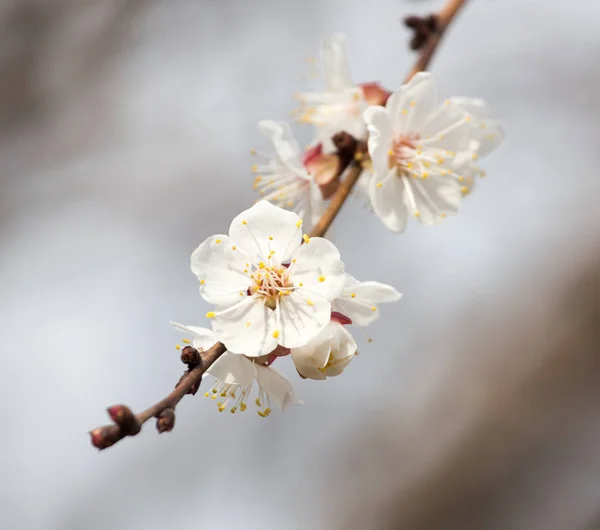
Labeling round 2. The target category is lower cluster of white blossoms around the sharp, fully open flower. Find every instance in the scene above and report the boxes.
[173,201,401,416]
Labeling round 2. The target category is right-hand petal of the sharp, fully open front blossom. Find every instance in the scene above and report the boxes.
[289,237,345,301]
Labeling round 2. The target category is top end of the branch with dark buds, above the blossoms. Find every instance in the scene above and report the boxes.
[404,0,467,83]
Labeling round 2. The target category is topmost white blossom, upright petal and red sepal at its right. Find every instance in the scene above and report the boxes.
[296,33,388,152]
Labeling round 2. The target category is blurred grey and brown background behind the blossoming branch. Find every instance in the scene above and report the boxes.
[0,0,600,530]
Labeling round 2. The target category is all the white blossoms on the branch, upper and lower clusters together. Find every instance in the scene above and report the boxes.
[173,34,504,416]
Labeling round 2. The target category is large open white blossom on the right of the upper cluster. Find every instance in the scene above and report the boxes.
[364,72,504,232]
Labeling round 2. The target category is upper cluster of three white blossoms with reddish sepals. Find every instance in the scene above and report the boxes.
[248,34,504,232]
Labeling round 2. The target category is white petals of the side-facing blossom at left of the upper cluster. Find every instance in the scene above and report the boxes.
[252,120,326,226]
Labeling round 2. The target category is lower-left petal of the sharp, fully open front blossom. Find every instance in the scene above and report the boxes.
[212,296,277,357]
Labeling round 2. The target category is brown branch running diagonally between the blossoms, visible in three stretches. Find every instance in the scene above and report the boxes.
[90,0,466,449]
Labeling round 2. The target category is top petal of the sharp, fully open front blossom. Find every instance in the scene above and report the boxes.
[229,201,302,263]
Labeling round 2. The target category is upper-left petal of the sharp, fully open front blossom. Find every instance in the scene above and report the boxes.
[190,235,252,306]
